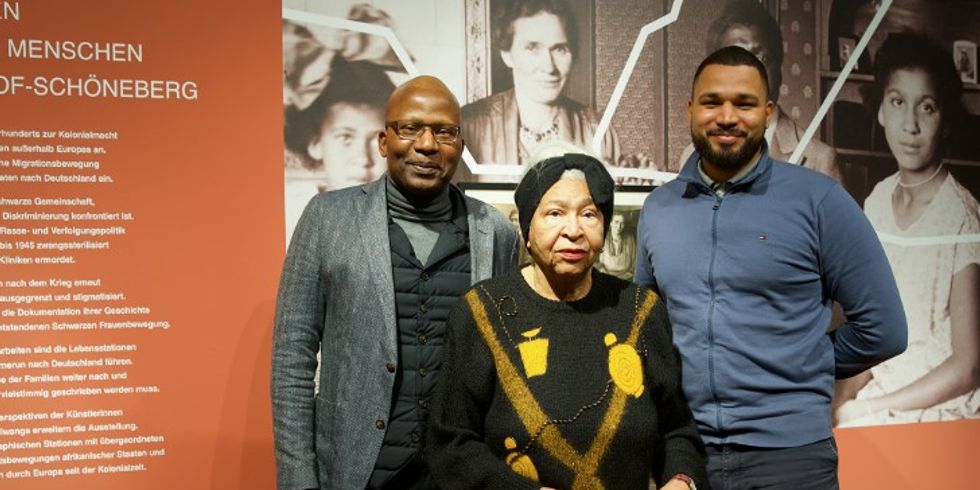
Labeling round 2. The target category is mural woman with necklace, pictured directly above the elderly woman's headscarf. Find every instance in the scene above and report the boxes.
[461,0,620,179]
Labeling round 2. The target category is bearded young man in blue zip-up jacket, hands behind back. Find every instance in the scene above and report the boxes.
[635,46,907,490]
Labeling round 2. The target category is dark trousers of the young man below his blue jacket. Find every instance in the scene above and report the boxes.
[706,437,840,490]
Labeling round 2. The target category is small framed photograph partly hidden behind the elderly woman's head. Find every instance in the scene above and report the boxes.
[459,182,653,281]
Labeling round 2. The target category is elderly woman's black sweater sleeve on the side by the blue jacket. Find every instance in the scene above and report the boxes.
[644,301,708,488]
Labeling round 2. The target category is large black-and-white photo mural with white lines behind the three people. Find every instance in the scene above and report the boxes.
[283,0,980,426]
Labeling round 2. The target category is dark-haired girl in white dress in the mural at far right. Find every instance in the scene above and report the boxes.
[836,33,980,425]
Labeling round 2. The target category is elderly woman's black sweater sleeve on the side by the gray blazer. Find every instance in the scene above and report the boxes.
[426,292,541,490]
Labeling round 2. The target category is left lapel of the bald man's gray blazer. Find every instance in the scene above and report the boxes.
[356,177,398,359]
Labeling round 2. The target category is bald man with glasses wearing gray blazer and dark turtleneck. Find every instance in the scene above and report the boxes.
[272,76,519,490]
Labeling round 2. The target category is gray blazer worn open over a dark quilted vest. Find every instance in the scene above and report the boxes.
[272,178,519,490]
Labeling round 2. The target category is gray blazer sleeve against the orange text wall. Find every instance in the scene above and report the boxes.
[271,196,326,489]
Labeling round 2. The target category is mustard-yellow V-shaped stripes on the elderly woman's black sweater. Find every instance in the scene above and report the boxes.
[465,290,657,490]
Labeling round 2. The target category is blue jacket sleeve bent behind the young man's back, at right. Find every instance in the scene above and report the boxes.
[818,185,908,379]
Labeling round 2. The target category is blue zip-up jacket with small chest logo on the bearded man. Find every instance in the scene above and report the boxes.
[635,148,908,447]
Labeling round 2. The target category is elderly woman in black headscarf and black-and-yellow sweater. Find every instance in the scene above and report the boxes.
[427,154,706,490]
